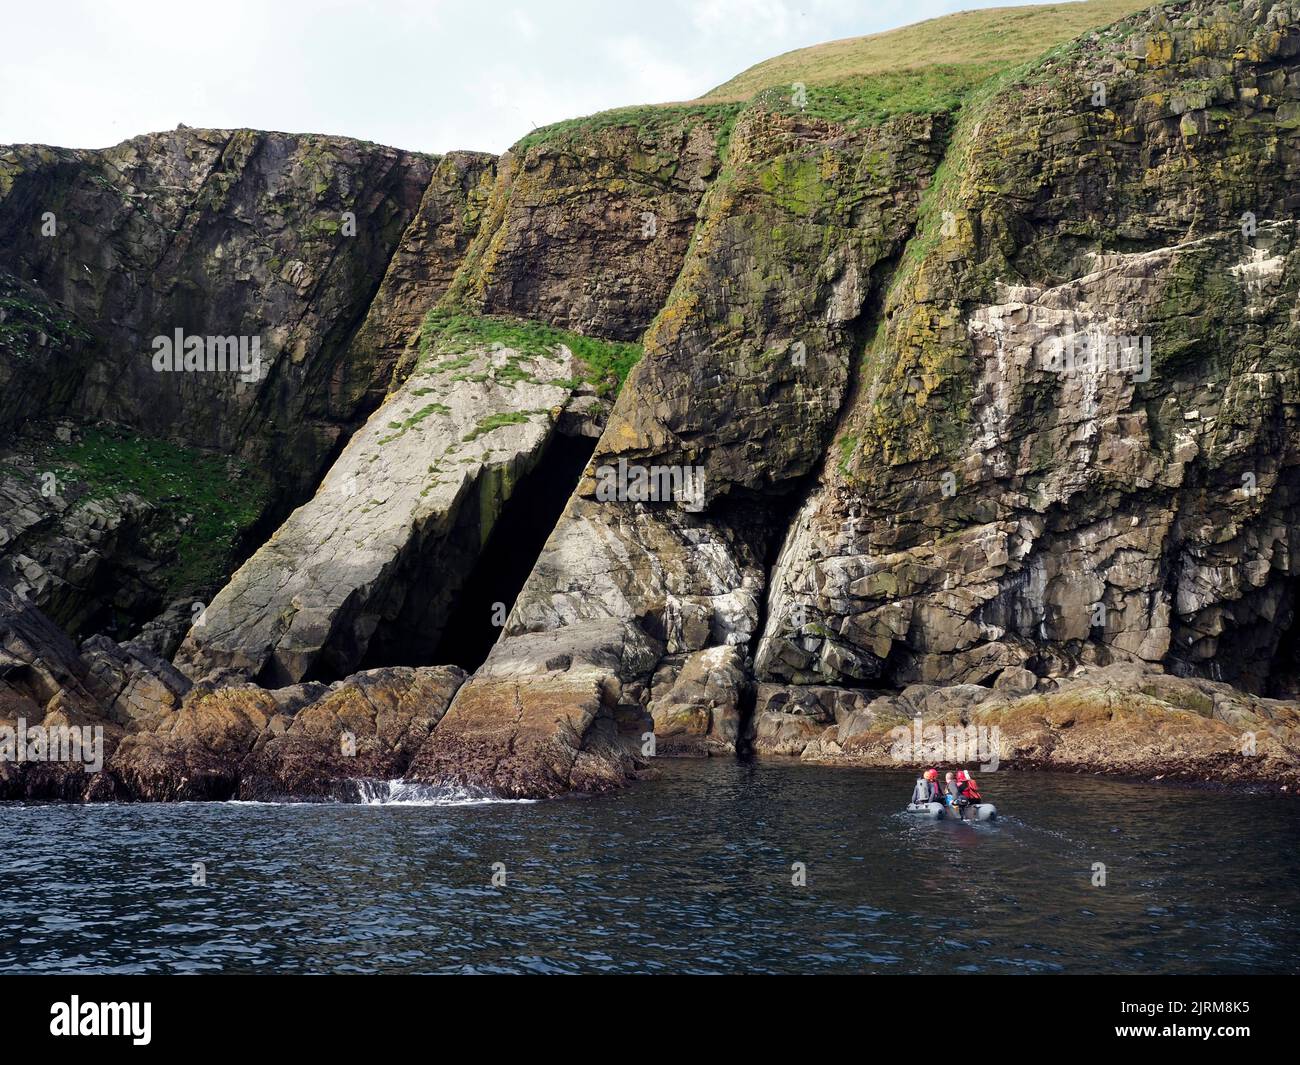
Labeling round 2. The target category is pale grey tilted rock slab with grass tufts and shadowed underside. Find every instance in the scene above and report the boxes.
[176,346,590,687]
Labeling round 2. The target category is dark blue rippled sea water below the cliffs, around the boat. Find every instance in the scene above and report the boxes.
[0,759,1300,973]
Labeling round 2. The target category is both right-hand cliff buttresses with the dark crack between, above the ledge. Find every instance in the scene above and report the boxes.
[478,5,1300,785]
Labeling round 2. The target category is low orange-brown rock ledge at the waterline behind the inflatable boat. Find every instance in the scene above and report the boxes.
[790,663,1300,787]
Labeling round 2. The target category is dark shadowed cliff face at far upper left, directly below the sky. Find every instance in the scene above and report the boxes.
[0,129,434,492]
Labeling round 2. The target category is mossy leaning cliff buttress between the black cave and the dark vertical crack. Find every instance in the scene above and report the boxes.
[473,108,943,783]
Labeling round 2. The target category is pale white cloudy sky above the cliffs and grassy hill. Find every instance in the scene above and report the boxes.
[0,0,1045,152]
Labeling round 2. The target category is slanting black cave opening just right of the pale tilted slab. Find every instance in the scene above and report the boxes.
[429,433,595,672]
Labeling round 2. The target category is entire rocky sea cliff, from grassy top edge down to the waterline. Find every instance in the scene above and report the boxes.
[0,0,1300,798]
